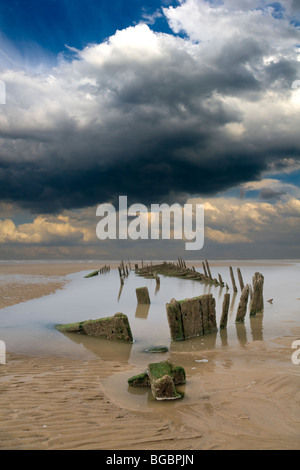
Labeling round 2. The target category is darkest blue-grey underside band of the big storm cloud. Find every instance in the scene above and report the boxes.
[0,148,263,213]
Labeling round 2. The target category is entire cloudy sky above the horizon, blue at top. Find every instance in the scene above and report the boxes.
[0,0,300,259]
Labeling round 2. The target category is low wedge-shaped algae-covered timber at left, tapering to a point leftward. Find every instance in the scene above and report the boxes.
[55,313,133,343]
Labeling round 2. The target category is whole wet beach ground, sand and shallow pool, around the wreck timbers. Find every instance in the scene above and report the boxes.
[0,261,300,450]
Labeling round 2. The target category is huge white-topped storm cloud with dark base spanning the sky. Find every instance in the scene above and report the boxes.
[0,0,300,213]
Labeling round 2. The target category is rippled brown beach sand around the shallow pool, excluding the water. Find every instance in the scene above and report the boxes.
[0,262,300,450]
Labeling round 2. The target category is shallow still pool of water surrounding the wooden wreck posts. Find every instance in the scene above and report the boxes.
[0,261,300,362]
